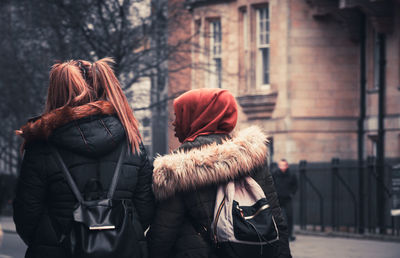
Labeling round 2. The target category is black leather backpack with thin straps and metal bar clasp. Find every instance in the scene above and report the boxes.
[52,144,145,258]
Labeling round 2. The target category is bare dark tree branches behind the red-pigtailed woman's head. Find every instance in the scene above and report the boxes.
[0,0,206,166]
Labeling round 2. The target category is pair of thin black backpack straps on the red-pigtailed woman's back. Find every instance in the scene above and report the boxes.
[50,144,126,203]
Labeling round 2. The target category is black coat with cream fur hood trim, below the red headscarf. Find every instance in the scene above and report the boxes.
[148,127,291,258]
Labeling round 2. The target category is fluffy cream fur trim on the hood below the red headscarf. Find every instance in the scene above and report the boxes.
[153,126,268,200]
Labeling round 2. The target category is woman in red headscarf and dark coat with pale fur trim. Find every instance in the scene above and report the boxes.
[147,89,291,258]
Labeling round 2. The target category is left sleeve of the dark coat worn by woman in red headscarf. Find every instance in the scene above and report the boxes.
[147,196,185,258]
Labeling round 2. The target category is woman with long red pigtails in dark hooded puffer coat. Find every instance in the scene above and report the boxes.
[14,58,154,258]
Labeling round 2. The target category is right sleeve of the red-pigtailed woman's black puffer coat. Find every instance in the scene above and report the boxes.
[133,144,155,230]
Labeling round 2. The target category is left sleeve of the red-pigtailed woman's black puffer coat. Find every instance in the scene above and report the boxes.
[13,150,46,245]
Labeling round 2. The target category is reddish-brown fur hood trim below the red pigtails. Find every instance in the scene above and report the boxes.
[15,100,115,143]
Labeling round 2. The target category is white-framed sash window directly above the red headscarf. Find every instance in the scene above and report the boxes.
[210,20,222,88]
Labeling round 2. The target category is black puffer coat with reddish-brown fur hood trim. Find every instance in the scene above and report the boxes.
[14,102,154,258]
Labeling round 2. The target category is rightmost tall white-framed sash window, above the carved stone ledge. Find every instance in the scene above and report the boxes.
[256,6,270,88]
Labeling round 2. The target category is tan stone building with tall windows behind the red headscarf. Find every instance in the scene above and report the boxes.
[168,0,400,167]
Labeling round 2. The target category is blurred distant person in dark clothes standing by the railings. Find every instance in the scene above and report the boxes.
[272,159,297,241]
